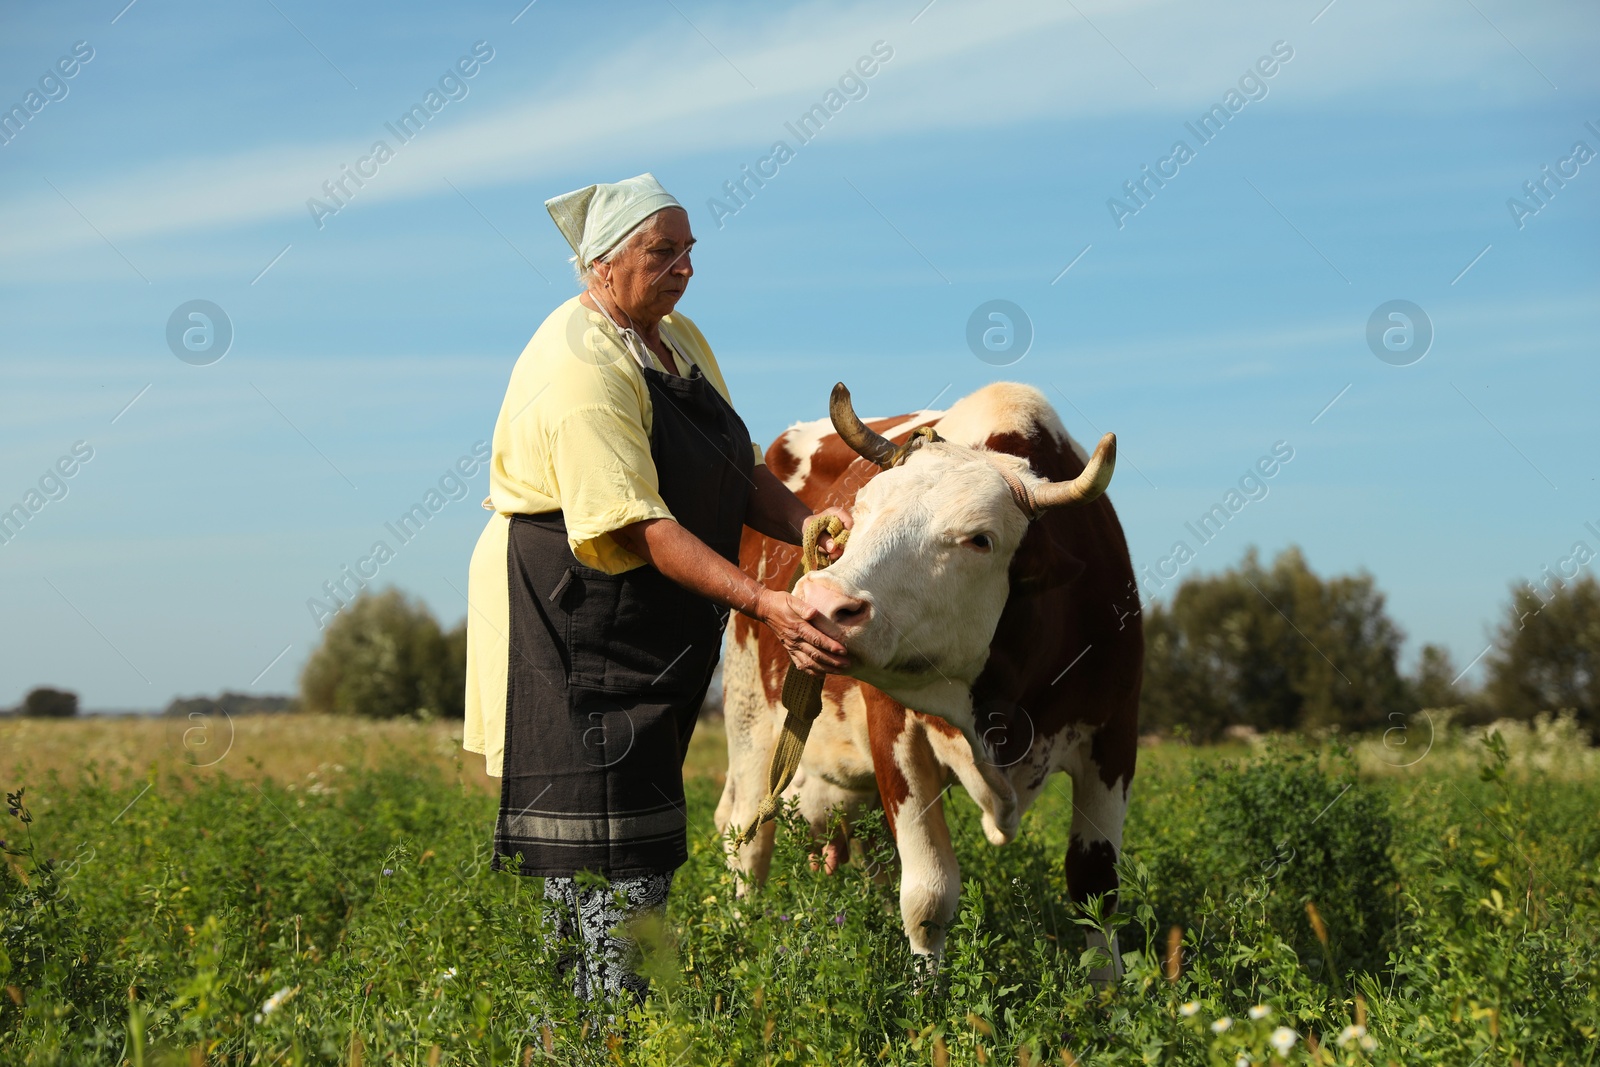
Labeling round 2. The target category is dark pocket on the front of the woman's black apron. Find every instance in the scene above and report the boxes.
[562,566,720,704]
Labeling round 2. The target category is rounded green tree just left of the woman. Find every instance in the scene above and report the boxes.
[301,589,467,718]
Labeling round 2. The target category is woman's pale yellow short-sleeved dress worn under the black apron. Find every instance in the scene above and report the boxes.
[462,296,762,777]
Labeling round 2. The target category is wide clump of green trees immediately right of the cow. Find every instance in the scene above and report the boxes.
[1141,547,1410,739]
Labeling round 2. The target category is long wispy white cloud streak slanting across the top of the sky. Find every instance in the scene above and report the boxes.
[0,0,1578,256]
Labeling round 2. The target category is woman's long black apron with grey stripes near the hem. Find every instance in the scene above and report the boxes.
[494,358,754,877]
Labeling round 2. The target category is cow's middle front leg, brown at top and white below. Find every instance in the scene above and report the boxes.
[869,712,962,973]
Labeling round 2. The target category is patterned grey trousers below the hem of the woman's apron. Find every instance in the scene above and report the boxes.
[544,870,672,1003]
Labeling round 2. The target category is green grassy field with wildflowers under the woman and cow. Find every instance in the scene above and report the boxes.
[0,715,1600,1067]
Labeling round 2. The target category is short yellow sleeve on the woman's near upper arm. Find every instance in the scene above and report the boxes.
[549,405,672,574]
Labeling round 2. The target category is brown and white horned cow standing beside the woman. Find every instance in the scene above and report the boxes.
[717,382,1144,982]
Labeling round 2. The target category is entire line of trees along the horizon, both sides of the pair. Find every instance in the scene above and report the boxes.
[14,547,1600,741]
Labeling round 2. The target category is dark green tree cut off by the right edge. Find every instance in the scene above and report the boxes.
[1483,574,1600,731]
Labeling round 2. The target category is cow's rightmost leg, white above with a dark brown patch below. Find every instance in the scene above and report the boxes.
[1066,726,1138,985]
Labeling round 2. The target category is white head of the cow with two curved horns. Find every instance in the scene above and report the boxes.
[795,384,1117,726]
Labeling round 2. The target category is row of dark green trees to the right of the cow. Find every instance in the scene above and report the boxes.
[1141,547,1600,741]
